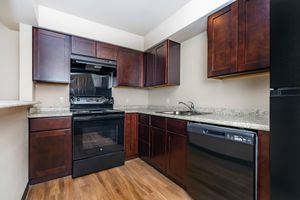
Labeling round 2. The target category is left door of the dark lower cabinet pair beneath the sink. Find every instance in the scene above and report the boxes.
[150,127,167,171]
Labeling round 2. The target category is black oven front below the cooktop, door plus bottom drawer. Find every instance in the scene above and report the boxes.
[73,111,124,177]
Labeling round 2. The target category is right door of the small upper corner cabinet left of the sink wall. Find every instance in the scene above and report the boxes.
[154,42,167,86]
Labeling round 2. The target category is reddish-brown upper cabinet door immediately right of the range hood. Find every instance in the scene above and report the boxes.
[117,48,143,87]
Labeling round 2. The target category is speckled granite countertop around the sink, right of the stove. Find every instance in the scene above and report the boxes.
[115,106,269,131]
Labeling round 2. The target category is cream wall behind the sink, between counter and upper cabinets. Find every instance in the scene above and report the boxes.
[149,32,269,111]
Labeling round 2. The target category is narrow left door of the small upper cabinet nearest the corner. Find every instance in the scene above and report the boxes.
[144,51,154,87]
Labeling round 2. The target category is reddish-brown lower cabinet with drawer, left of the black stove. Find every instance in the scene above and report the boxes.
[29,117,72,184]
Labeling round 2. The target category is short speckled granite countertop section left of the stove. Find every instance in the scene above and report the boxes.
[28,108,72,118]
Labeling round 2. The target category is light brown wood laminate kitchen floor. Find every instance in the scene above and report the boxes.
[27,159,191,200]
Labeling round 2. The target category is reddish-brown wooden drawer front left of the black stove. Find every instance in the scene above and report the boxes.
[29,117,72,132]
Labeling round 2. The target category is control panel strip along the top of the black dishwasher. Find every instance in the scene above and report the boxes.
[187,122,256,145]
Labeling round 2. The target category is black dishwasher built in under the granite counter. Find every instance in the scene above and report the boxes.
[187,123,257,200]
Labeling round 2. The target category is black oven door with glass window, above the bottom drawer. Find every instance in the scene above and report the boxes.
[73,117,124,160]
